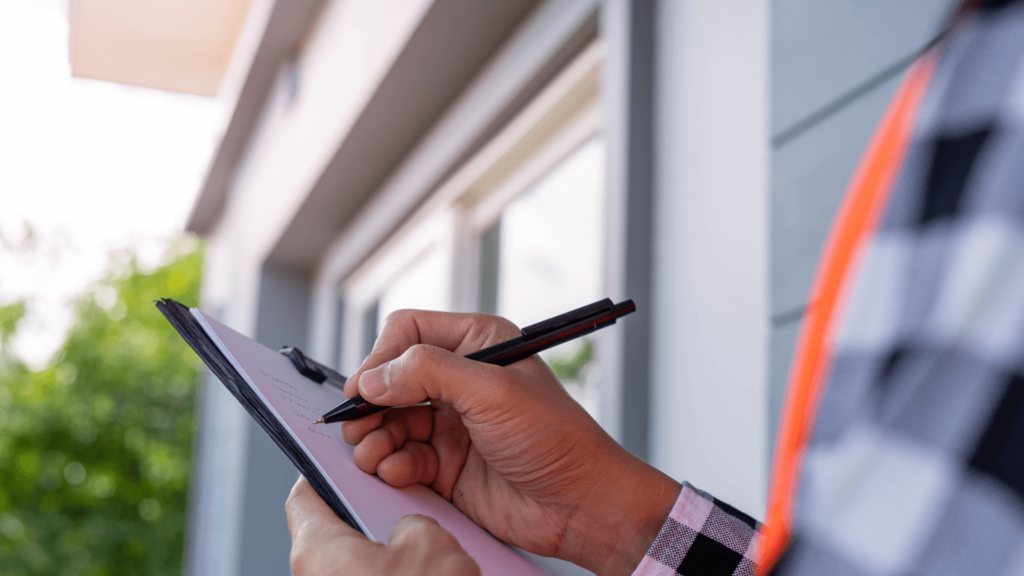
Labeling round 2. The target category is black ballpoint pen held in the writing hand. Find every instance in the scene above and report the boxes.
[313,298,637,424]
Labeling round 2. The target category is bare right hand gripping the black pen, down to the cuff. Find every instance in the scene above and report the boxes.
[329,311,680,574]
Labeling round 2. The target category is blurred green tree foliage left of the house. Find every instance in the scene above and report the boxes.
[0,242,202,576]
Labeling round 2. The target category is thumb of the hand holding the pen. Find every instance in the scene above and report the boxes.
[358,344,509,414]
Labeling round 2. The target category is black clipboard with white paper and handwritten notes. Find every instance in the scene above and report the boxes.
[157,299,569,576]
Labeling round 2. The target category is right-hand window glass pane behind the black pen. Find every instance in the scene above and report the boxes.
[493,136,605,416]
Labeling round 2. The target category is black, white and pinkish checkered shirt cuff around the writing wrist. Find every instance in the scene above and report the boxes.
[633,483,764,576]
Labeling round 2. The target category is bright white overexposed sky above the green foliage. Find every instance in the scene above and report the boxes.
[0,0,224,365]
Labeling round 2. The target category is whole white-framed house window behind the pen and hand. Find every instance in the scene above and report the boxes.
[341,44,606,417]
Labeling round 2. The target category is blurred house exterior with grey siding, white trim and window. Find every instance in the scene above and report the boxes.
[180,0,951,575]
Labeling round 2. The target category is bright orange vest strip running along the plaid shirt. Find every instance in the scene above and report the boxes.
[758,53,937,575]
